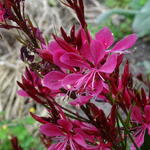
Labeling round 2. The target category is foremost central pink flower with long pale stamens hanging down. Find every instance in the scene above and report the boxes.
[60,44,117,96]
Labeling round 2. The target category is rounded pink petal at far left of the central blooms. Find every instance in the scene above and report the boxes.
[43,71,66,90]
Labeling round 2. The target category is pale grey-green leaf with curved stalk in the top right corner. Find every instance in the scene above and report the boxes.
[96,0,150,37]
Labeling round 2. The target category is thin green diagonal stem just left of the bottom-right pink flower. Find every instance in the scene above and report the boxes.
[117,113,140,150]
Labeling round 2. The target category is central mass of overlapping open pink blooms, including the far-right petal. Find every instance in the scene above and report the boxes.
[43,27,137,105]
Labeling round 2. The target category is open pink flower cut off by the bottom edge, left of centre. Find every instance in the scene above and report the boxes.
[40,119,87,150]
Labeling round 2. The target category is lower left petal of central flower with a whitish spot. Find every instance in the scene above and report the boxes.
[62,73,83,90]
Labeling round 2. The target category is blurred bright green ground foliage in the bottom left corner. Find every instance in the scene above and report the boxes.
[0,117,44,150]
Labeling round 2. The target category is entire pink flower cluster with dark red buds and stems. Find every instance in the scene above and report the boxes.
[0,0,150,150]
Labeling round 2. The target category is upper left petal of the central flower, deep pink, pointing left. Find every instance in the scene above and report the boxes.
[60,53,89,67]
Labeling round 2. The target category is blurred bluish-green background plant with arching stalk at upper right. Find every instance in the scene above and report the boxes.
[97,1,150,37]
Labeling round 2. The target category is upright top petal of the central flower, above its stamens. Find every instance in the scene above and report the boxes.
[91,40,105,65]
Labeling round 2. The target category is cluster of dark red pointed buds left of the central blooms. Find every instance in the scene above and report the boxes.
[17,68,59,104]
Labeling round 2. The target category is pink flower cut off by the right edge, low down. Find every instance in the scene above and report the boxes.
[131,105,150,150]
